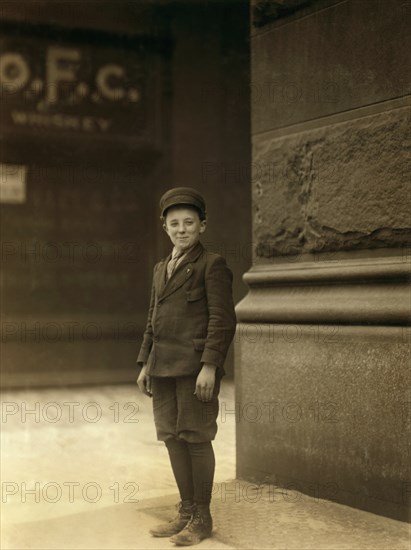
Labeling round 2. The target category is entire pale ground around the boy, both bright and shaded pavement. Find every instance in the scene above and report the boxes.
[1,382,411,550]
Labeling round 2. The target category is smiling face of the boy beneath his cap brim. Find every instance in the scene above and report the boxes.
[163,206,206,252]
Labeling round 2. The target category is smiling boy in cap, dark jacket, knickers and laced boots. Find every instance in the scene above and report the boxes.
[137,187,236,546]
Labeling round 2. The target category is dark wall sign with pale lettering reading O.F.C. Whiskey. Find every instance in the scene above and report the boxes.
[0,35,160,147]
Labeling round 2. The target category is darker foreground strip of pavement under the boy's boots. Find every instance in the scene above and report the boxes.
[3,481,410,550]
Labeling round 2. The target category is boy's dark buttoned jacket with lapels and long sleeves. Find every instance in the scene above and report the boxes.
[137,242,236,376]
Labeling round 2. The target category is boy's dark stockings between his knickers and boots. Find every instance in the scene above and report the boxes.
[166,438,215,504]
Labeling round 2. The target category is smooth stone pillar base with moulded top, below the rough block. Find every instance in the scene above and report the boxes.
[235,256,411,520]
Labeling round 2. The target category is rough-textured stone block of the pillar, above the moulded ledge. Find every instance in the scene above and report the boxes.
[253,107,411,258]
